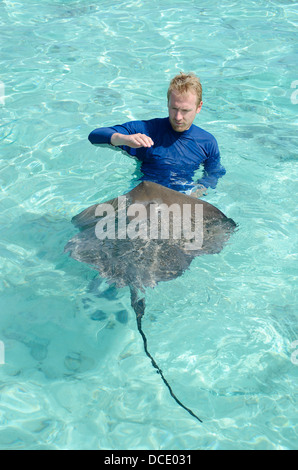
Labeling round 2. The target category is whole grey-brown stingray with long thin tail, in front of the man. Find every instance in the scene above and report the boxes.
[64,181,236,422]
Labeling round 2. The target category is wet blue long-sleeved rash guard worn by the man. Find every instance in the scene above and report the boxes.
[89,117,226,192]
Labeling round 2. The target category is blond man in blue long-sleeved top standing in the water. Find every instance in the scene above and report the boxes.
[89,72,226,197]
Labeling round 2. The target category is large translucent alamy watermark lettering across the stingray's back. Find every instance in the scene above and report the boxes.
[95,196,203,250]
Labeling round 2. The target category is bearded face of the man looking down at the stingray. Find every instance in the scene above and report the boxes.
[168,91,203,132]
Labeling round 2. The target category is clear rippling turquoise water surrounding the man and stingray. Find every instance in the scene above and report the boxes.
[0,0,298,450]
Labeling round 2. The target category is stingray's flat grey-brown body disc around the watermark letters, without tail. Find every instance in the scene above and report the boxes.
[65,182,236,289]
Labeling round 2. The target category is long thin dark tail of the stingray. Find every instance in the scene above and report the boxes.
[130,287,203,423]
